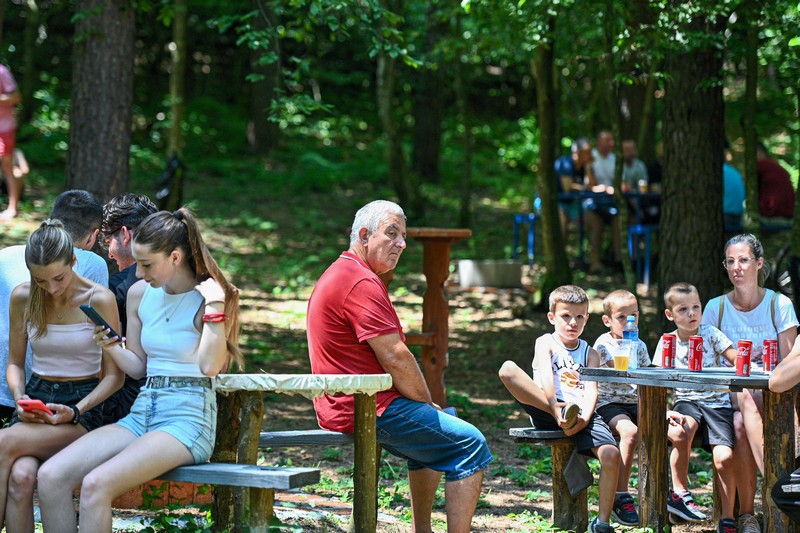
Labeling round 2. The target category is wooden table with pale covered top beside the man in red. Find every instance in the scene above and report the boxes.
[214,374,392,532]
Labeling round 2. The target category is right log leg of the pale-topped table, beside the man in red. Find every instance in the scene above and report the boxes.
[350,394,378,533]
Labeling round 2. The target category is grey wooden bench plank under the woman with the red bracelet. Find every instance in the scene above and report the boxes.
[158,463,320,490]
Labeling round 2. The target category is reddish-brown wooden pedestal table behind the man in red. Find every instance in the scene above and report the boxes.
[381,228,472,407]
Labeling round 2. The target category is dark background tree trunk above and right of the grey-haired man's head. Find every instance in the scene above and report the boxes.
[411,1,450,183]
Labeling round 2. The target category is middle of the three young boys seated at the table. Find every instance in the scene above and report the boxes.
[594,290,683,526]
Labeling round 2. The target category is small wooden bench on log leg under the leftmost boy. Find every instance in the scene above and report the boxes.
[508,427,589,531]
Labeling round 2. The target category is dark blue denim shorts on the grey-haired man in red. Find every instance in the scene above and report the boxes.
[377,398,492,481]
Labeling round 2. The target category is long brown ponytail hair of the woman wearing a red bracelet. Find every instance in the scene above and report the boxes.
[133,207,244,370]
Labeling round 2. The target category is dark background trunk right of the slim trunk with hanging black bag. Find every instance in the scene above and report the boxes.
[247,0,282,156]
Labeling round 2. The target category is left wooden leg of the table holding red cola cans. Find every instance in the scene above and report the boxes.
[639,385,669,531]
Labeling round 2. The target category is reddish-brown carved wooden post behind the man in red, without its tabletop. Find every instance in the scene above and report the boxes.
[421,238,451,407]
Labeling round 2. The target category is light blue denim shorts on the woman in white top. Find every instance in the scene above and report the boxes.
[117,378,217,463]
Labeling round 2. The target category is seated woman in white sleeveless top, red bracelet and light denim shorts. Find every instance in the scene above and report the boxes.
[39,208,241,533]
